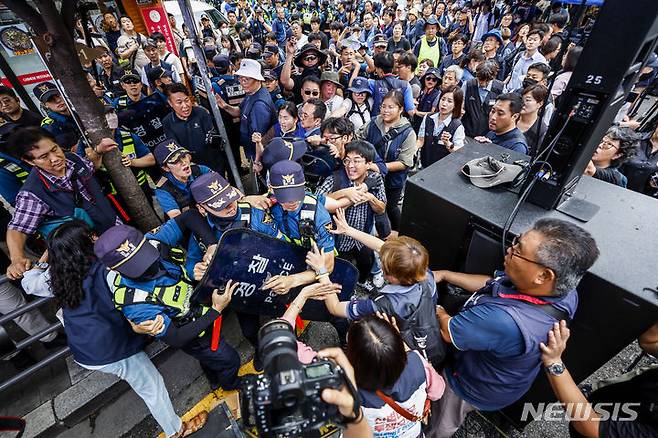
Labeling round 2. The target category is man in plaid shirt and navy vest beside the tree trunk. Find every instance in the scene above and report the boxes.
[7,127,120,279]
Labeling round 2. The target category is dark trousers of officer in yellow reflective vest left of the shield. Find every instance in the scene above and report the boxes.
[182,336,240,391]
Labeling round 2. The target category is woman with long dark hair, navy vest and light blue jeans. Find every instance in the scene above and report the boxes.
[43,221,208,437]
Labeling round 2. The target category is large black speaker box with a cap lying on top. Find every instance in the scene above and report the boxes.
[400,142,658,425]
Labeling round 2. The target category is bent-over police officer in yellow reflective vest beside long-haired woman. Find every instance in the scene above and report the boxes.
[94,218,240,390]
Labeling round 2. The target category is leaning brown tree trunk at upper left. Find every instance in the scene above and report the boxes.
[3,0,160,232]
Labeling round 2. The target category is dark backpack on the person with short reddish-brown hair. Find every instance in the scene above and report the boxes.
[374,281,447,369]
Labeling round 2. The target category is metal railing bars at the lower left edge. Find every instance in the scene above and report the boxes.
[0,275,71,394]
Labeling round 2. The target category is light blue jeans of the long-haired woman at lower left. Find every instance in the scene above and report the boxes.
[80,351,183,437]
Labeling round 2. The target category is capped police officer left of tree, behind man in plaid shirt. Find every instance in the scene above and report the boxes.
[33,82,80,151]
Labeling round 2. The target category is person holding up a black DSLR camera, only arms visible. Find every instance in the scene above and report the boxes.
[240,278,373,438]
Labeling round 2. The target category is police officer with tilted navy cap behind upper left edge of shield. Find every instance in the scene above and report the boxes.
[188,172,285,354]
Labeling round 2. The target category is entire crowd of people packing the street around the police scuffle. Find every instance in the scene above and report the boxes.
[0,0,658,437]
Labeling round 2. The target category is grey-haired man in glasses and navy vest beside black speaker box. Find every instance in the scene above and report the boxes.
[428,219,599,438]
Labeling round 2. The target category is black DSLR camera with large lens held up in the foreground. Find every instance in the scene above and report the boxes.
[240,319,357,437]
